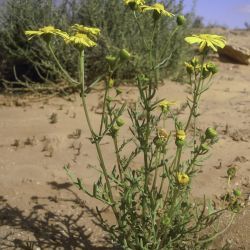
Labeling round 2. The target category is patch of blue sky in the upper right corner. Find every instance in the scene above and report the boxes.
[184,0,250,28]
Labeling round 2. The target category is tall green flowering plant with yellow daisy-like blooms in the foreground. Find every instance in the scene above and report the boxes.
[25,0,240,250]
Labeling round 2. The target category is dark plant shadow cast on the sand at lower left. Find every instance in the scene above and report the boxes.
[0,182,118,250]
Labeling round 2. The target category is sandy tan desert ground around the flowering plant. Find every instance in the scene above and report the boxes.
[0,56,250,250]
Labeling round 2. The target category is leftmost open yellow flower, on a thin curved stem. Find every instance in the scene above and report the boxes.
[24,26,67,40]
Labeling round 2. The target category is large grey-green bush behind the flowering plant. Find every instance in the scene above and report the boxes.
[0,0,192,92]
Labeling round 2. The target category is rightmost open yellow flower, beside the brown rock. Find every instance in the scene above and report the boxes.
[185,34,226,52]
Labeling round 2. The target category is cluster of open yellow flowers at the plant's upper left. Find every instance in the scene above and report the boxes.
[25,24,100,49]
